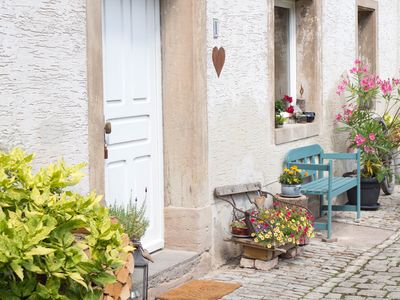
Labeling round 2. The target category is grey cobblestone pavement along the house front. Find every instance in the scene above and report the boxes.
[206,192,400,300]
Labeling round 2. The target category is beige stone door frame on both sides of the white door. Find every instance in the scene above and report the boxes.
[86,0,212,252]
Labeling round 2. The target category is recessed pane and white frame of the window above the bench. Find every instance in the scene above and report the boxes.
[274,0,296,99]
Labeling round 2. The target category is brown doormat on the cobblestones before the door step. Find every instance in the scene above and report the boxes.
[156,280,240,300]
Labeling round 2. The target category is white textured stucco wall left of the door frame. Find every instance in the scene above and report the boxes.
[0,0,88,190]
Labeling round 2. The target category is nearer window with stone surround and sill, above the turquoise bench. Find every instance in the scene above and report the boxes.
[269,0,322,145]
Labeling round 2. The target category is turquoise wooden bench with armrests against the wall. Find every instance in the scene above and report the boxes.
[284,144,361,242]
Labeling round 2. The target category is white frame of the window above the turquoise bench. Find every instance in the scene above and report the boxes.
[274,0,297,104]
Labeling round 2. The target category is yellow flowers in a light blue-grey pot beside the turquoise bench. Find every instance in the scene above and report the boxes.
[279,166,308,197]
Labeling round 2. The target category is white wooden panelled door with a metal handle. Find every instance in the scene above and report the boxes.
[103,0,164,251]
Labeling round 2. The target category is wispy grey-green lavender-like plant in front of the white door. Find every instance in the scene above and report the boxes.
[110,199,149,240]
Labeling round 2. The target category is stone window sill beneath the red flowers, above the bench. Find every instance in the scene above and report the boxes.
[275,121,319,145]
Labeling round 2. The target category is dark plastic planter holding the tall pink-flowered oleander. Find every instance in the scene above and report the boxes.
[343,173,381,210]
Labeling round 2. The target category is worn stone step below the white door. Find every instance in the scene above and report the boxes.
[149,249,211,299]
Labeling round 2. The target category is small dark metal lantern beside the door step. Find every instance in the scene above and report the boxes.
[131,242,149,300]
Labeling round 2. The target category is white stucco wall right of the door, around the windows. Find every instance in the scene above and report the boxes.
[207,0,399,264]
